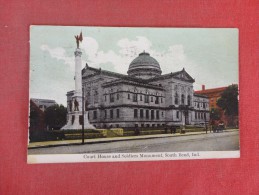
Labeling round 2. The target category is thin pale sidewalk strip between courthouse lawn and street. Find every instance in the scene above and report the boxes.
[28,129,238,149]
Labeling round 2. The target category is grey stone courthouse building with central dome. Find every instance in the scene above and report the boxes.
[67,52,209,128]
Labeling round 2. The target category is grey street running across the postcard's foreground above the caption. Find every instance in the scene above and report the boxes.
[28,131,239,154]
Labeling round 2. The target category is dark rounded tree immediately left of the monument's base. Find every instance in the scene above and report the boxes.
[45,104,67,129]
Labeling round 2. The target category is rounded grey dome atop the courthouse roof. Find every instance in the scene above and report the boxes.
[128,52,162,79]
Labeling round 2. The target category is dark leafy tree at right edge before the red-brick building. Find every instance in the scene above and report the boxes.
[217,85,238,117]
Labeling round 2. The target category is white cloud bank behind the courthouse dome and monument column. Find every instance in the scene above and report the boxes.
[41,36,197,77]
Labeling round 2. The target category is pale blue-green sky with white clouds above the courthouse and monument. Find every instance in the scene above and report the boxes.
[30,25,238,106]
